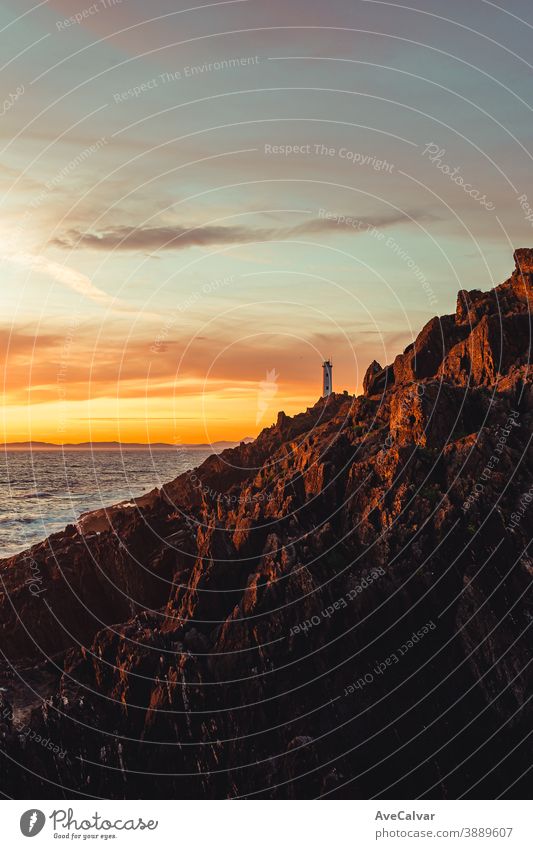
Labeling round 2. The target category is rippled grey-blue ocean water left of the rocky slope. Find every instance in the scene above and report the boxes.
[0,448,213,558]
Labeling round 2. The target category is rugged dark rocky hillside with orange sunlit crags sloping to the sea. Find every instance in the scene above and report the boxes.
[0,249,533,798]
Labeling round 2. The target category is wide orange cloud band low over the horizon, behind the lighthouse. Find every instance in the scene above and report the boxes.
[0,322,409,408]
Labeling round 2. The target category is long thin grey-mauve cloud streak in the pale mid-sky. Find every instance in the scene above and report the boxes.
[48,212,429,251]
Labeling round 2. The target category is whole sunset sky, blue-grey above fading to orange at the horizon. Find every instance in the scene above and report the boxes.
[0,0,533,443]
